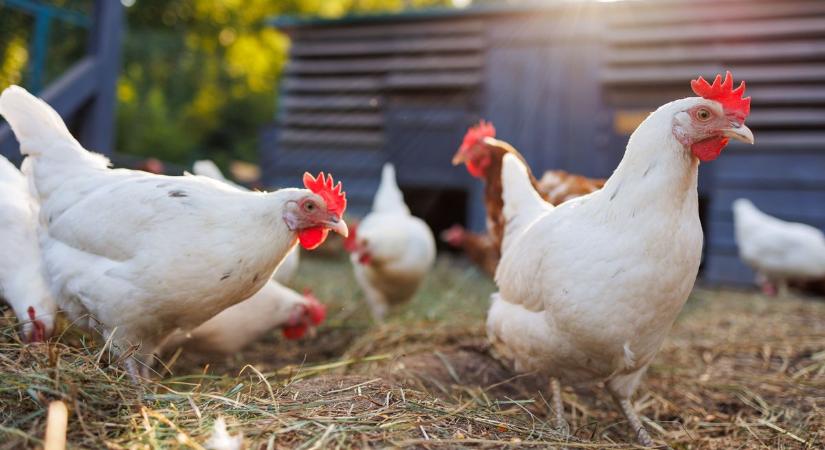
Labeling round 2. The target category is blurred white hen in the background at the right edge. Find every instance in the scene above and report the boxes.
[733,198,825,296]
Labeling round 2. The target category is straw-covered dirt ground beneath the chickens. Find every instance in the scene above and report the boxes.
[0,258,825,449]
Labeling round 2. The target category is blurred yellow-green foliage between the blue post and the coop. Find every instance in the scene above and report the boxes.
[117,0,450,164]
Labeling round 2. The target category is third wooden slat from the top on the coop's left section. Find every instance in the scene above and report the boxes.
[286,54,484,75]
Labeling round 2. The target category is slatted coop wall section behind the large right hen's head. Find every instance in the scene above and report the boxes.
[600,0,825,283]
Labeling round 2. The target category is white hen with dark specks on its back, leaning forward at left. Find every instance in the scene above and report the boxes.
[0,86,347,379]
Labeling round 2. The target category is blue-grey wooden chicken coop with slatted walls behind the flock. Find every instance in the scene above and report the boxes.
[261,0,825,283]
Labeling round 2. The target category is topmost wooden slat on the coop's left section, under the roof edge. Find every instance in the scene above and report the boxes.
[290,19,484,42]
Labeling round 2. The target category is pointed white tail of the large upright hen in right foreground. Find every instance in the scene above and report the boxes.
[501,154,553,251]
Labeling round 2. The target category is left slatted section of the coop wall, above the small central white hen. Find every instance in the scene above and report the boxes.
[263,18,484,215]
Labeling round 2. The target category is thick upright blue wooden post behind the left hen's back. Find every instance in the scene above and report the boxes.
[81,0,123,155]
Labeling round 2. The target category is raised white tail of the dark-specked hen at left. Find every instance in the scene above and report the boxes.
[0,86,109,167]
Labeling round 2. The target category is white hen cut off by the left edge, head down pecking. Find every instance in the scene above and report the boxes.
[0,156,57,342]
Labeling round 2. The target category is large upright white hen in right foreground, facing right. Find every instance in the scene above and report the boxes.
[487,73,753,446]
